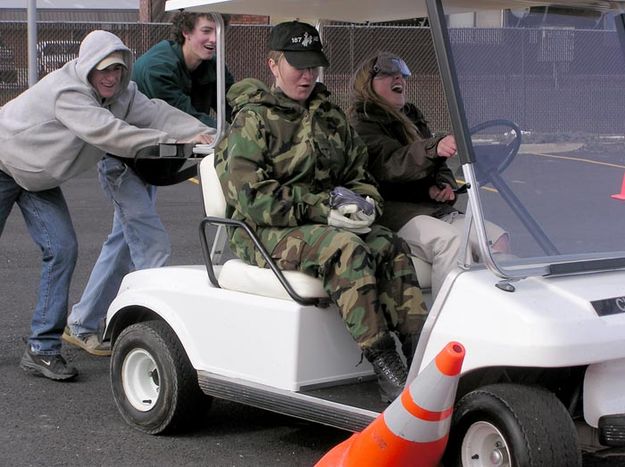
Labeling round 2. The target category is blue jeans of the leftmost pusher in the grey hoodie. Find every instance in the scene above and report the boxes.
[0,171,78,355]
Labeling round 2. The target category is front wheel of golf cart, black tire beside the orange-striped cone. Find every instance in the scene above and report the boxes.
[444,384,582,467]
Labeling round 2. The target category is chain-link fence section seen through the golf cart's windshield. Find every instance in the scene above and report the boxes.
[450,28,625,135]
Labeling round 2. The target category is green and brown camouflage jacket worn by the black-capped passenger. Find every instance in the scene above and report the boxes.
[215,79,382,266]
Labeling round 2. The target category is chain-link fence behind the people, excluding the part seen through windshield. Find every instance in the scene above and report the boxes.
[0,22,449,130]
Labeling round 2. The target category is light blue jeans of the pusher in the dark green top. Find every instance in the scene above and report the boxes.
[67,156,171,335]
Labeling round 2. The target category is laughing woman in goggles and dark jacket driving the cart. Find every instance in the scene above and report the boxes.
[350,52,508,297]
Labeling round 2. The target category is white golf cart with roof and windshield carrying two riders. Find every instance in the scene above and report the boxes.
[105,0,625,466]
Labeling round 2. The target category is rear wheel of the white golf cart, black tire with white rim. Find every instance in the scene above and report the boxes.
[111,321,212,434]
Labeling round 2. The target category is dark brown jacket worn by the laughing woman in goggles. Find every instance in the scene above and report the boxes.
[350,103,458,231]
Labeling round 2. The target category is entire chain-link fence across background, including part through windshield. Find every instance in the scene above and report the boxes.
[0,22,625,134]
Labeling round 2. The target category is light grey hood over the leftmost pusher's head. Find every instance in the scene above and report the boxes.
[76,30,133,97]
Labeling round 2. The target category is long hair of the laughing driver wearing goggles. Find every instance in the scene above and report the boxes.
[350,52,421,143]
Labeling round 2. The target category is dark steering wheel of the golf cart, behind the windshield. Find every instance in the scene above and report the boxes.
[469,119,521,184]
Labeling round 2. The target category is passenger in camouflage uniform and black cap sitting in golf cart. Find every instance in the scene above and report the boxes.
[215,21,427,401]
